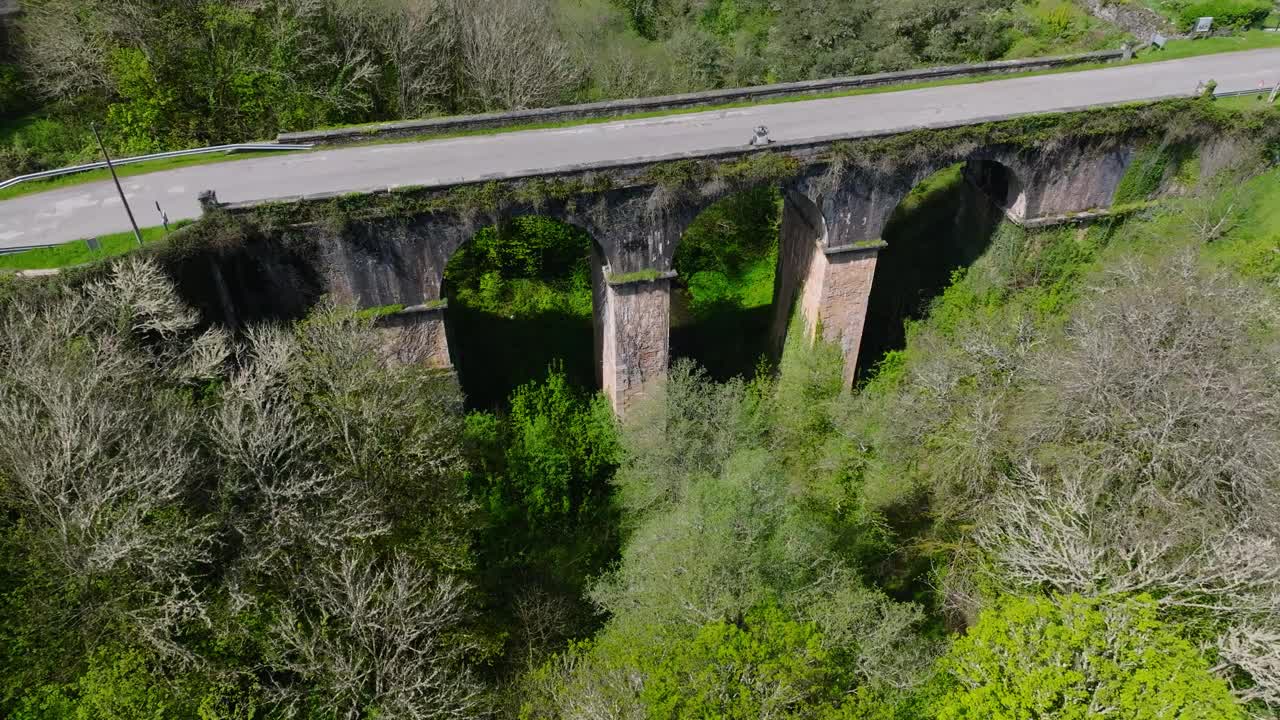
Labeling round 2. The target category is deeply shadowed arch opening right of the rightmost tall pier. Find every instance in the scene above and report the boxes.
[858,156,1025,380]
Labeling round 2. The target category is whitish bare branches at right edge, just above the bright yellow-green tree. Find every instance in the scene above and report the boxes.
[975,468,1280,618]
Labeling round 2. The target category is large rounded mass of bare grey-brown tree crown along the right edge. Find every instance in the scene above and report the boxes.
[972,255,1280,702]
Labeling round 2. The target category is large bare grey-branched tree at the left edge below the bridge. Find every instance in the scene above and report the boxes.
[0,261,220,656]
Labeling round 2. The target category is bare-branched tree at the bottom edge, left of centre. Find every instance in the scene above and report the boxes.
[270,552,486,720]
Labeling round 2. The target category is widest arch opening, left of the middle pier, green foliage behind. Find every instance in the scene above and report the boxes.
[440,215,596,410]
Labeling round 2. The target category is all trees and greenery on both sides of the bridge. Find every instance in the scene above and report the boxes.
[0,0,1280,720]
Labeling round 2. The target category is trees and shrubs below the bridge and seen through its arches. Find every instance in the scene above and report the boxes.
[0,101,1280,720]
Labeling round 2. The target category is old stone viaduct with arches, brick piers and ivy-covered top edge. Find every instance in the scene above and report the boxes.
[179,109,1203,413]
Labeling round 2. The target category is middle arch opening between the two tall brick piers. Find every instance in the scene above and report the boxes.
[671,187,782,380]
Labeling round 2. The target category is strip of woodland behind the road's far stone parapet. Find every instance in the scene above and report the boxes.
[0,0,1119,177]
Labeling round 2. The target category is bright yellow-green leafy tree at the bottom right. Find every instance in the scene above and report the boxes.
[937,596,1243,720]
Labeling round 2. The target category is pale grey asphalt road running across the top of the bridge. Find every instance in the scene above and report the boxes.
[0,50,1280,247]
